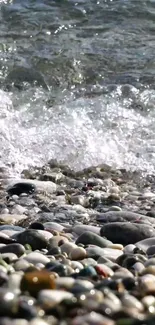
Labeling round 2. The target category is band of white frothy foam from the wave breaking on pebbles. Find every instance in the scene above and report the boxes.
[0,86,155,172]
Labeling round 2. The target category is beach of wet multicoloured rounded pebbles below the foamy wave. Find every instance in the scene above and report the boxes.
[0,160,155,325]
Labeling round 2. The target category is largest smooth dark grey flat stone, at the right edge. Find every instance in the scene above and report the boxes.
[101,222,155,246]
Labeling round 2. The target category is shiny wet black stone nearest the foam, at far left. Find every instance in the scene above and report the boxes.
[7,182,36,196]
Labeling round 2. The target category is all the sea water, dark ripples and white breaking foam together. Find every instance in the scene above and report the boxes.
[0,0,155,173]
